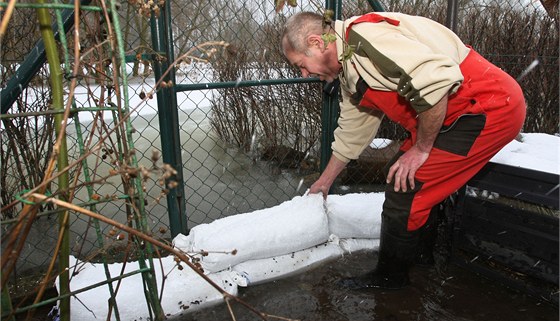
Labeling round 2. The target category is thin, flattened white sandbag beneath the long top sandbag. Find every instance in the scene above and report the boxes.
[230,242,342,287]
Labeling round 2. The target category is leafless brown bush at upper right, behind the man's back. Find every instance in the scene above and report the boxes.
[459,8,559,134]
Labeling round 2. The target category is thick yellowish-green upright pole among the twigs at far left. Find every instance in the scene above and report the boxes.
[37,0,70,321]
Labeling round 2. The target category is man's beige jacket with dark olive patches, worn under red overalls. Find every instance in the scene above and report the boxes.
[332,12,470,162]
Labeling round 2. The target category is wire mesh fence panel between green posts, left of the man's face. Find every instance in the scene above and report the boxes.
[172,1,322,226]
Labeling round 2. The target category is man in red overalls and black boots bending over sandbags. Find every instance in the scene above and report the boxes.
[282,12,526,289]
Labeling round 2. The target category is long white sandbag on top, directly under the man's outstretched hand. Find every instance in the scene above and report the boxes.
[173,194,329,272]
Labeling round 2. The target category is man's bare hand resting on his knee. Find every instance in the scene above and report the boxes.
[387,146,430,192]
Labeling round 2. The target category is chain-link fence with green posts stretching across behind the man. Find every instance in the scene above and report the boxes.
[0,0,558,310]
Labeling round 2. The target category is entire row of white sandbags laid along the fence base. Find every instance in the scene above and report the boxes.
[61,193,384,320]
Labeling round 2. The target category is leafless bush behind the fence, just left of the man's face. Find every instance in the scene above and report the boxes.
[211,24,321,167]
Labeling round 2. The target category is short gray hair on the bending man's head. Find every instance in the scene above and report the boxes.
[282,12,323,54]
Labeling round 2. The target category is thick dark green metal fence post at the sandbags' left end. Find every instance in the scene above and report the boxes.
[151,1,187,237]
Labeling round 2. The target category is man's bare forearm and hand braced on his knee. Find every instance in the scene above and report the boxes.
[387,95,447,192]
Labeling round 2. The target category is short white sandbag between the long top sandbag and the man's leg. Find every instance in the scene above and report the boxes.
[326,193,385,239]
